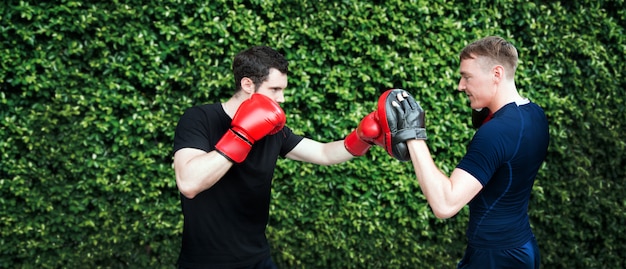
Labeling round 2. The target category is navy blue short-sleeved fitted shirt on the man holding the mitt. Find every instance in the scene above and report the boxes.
[457,100,550,249]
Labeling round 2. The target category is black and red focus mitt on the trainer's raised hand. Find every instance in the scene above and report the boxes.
[377,89,427,161]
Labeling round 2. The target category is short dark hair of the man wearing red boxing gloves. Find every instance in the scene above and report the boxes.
[233,46,289,92]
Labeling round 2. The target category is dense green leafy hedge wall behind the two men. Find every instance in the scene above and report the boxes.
[0,0,626,268]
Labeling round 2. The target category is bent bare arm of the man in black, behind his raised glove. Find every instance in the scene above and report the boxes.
[174,148,233,199]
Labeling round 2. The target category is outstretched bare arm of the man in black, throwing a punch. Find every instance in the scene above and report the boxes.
[286,138,354,165]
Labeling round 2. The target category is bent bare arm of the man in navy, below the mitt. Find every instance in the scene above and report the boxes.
[407,140,483,219]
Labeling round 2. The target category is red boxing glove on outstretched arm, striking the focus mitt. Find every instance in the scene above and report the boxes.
[343,111,384,156]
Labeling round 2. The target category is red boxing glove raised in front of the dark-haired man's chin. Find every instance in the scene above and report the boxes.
[215,93,286,163]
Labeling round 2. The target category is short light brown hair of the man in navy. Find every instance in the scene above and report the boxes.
[459,36,518,78]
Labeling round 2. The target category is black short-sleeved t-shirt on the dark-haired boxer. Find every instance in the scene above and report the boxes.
[174,103,303,268]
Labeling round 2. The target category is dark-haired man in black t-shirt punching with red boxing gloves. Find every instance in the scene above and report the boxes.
[174,46,388,268]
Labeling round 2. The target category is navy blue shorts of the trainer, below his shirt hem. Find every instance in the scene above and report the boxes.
[456,237,541,269]
